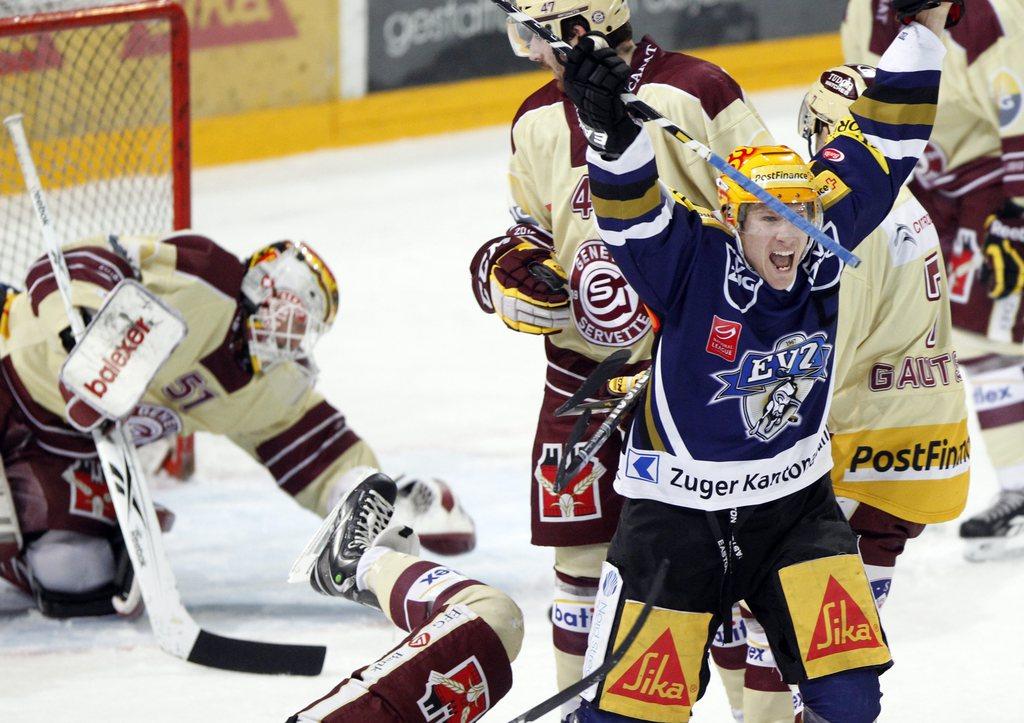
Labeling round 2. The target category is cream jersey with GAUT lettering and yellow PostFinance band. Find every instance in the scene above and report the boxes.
[823,187,971,523]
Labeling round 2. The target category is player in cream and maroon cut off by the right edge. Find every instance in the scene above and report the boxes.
[842,0,1024,560]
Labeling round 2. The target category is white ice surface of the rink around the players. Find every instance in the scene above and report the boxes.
[0,90,1024,723]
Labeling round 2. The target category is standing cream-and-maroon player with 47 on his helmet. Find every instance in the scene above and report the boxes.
[470,0,772,699]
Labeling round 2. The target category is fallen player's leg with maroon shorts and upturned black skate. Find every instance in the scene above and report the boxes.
[289,469,522,723]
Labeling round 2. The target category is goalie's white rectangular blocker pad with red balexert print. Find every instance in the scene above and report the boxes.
[60,279,188,419]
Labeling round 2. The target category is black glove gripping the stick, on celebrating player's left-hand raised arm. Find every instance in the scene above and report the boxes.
[562,35,640,159]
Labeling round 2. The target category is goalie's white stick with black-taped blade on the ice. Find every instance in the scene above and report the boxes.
[4,115,327,675]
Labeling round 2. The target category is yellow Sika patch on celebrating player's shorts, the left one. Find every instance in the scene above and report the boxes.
[598,600,711,721]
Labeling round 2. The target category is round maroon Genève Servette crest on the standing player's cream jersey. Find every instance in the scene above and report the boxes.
[569,239,651,346]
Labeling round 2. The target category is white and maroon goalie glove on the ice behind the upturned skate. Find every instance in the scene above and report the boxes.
[394,477,476,555]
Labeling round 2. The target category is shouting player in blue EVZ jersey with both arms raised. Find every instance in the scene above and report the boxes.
[565,0,950,723]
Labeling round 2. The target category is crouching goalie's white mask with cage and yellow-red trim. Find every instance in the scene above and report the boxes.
[242,241,338,374]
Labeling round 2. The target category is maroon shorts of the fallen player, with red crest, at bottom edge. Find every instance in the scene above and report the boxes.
[294,605,512,723]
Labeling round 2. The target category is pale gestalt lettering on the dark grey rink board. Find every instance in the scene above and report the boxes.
[383,0,506,57]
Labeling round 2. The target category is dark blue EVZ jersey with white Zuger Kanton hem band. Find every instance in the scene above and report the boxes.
[587,24,944,510]
